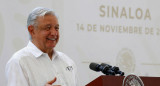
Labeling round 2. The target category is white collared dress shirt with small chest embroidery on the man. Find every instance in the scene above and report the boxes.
[6,41,77,86]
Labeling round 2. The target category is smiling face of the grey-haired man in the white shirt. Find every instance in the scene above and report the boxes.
[31,15,59,52]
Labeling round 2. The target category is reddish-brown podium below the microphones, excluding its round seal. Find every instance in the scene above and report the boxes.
[86,75,160,86]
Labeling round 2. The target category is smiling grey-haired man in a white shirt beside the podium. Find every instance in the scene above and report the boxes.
[6,7,77,86]
